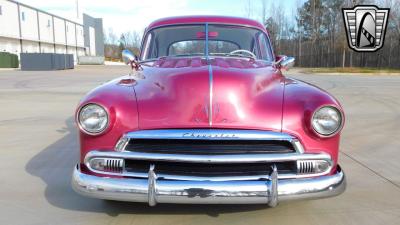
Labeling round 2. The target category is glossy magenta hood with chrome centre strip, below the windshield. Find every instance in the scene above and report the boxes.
[135,58,284,131]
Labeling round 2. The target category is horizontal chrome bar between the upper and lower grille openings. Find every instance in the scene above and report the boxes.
[84,151,332,164]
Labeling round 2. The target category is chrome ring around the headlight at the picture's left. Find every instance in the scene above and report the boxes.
[76,103,110,136]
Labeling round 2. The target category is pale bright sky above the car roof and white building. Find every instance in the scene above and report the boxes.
[17,0,304,35]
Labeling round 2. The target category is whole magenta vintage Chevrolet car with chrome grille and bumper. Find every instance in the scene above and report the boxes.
[72,16,346,207]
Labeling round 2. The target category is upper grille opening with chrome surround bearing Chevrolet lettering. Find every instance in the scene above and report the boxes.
[120,129,303,155]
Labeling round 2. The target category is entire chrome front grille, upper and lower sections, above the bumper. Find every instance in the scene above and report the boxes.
[85,129,332,180]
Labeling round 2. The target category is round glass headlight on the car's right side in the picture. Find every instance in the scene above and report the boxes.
[311,106,342,136]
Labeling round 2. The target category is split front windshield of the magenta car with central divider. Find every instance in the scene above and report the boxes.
[141,24,273,61]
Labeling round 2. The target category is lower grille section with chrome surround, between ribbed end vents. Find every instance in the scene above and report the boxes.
[84,151,332,180]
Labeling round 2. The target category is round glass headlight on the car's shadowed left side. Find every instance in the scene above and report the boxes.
[78,104,108,135]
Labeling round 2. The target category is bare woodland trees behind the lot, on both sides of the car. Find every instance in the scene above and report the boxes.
[104,0,400,68]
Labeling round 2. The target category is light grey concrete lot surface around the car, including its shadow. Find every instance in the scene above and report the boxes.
[0,66,400,225]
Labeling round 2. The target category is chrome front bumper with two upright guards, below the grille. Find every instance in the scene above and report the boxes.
[72,165,346,207]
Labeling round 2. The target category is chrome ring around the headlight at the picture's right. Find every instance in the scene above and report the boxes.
[310,105,344,138]
